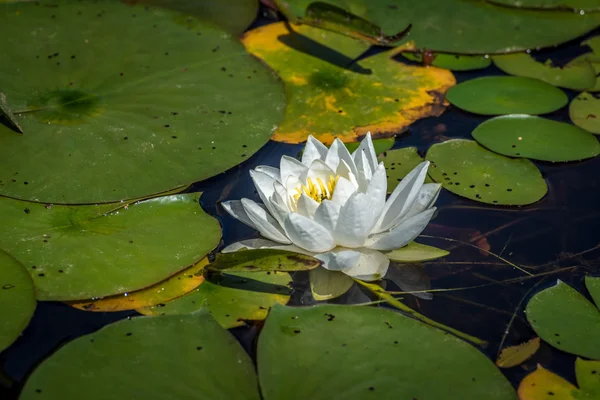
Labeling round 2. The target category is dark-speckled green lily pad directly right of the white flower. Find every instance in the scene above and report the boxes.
[425,139,548,205]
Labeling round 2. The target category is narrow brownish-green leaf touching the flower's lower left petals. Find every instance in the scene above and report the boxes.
[207,249,321,272]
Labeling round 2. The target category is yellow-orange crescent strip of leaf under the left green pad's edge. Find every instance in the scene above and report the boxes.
[68,257,208,312]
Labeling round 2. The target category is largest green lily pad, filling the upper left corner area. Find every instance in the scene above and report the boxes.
[0,0,285,204]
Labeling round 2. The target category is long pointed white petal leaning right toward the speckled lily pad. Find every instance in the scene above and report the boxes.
[374,161,429,232]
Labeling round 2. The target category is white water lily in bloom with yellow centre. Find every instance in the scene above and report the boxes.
[223,134,440,281]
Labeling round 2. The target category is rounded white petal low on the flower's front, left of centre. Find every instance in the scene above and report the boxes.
[284,213,335,253]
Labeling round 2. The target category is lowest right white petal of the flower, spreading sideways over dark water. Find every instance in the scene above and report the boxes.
[365,207,436,250]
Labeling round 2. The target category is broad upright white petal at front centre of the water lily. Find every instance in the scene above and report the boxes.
[333,192,375,248]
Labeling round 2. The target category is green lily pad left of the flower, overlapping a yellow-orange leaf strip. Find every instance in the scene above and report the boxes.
[0,193,221,300]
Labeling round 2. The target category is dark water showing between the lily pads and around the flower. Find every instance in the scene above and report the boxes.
[0,6,600,400]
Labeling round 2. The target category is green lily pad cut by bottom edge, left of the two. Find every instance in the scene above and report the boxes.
[20,313,260,400]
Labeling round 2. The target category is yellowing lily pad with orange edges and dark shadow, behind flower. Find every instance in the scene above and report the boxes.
[243,23,455,144]
